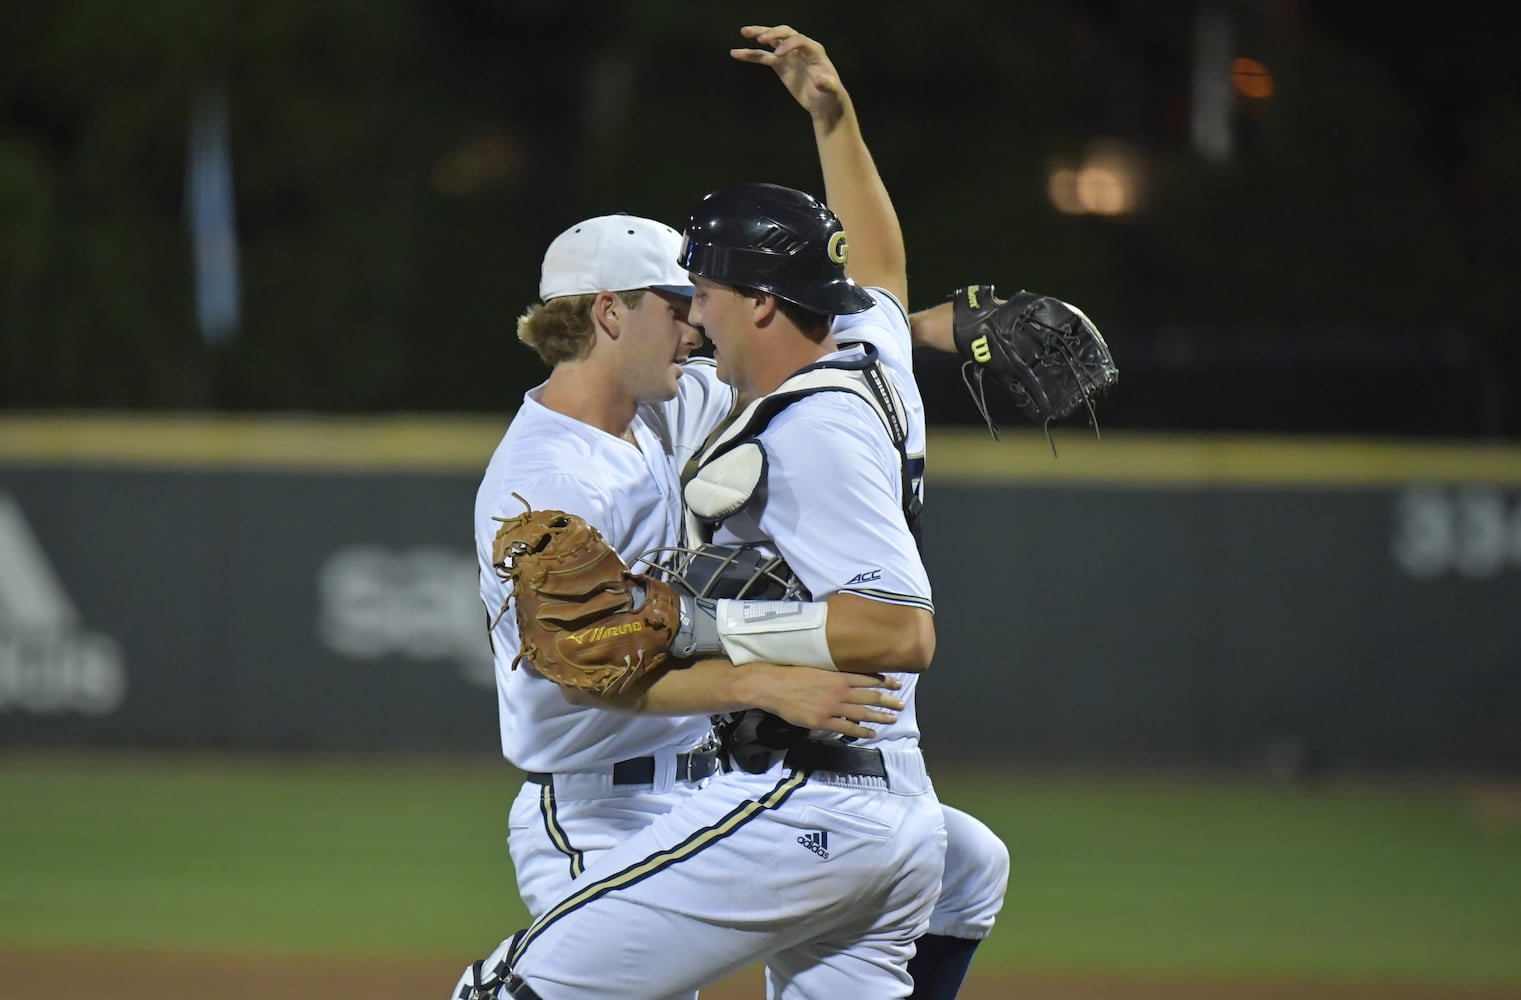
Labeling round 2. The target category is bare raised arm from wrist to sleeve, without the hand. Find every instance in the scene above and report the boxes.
[814,96,908,307]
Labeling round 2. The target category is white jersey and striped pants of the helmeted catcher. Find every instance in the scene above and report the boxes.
[493,286,946,1000]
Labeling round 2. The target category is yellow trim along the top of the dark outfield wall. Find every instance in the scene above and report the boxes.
[0,416,1521,490]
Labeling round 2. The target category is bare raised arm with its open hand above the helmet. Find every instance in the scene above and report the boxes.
[730,24,908,307]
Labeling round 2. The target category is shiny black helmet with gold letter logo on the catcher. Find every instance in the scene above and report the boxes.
[678,184,875,315]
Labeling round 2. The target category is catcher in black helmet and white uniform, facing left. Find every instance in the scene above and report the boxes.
[462,179,945,1000]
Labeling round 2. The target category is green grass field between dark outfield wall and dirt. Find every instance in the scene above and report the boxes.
[0,755,1521,995]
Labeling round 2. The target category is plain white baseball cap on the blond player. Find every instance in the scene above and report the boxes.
[538,213,692,301]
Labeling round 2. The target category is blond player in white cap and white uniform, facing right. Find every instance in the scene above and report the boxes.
[475,208,896,915]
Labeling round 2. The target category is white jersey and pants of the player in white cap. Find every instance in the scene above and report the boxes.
[475,359,733,915]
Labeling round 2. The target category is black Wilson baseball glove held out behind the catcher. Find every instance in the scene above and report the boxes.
[952,285,1119,438]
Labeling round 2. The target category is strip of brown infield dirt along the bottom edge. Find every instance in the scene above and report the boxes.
[0,951,1521,1000]
